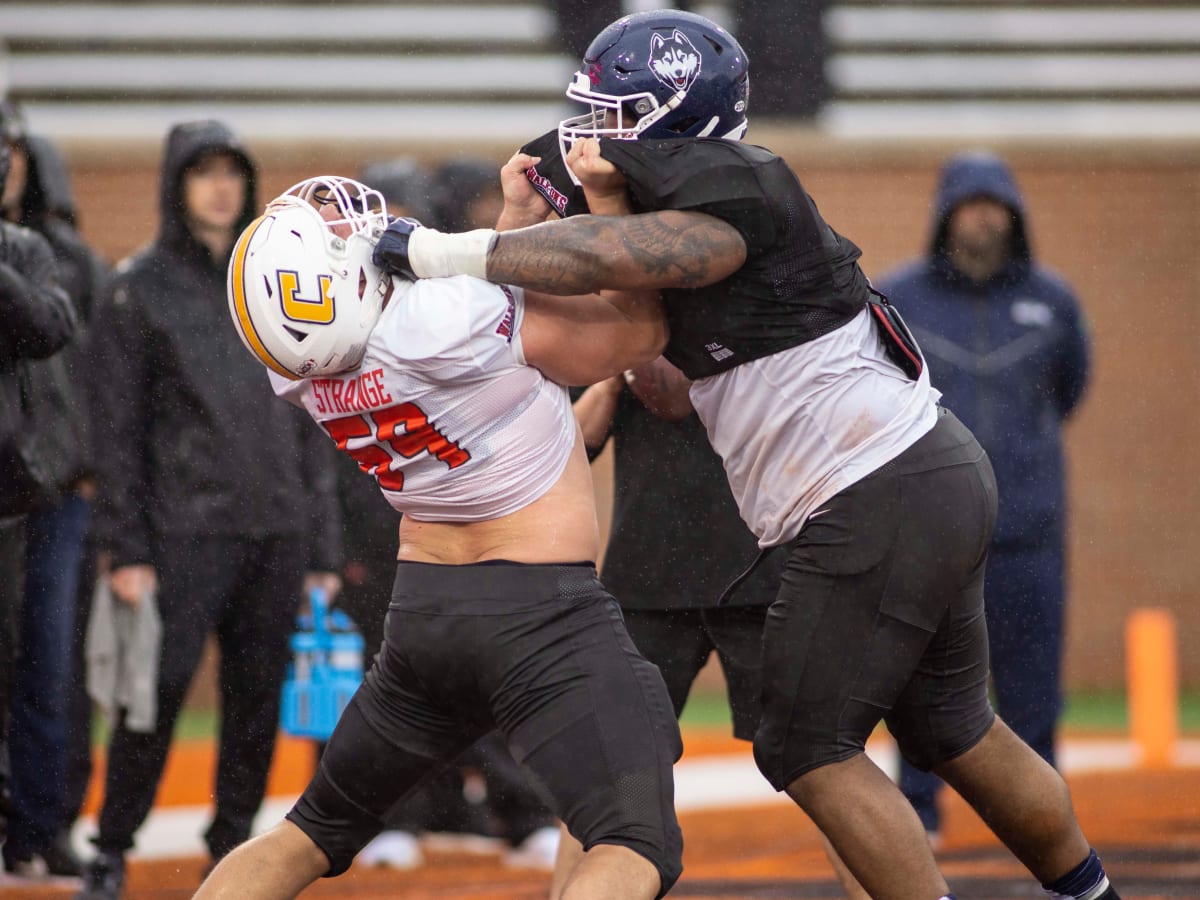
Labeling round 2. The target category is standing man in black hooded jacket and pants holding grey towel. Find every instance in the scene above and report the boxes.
[79,121,341,900]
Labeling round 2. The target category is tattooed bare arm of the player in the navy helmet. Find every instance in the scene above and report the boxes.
[487,211,745,294]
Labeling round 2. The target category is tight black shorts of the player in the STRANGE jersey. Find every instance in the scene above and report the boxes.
[288,563,683,893]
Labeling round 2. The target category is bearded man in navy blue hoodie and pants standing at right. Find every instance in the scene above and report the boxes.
[876,151,1088,841]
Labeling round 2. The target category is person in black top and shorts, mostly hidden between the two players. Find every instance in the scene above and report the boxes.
[558,356,782,888]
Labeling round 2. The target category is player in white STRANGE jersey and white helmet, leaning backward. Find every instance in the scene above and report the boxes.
[197,176,682,900]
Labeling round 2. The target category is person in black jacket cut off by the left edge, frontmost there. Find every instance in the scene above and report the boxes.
[0,140,78,868]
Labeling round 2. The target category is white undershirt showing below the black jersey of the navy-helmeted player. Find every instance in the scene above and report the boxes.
[691,308,941,547]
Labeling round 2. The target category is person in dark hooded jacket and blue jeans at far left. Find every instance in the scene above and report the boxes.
[0,103,106,878]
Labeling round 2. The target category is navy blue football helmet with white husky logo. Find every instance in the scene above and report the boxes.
[558,10,750,157]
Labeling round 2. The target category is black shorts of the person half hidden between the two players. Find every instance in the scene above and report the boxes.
[625,605,767,740]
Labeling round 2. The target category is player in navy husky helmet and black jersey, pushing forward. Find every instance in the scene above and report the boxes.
[376,11,1117,900]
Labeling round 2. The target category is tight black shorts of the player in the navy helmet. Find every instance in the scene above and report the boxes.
[755,409,996,791]
